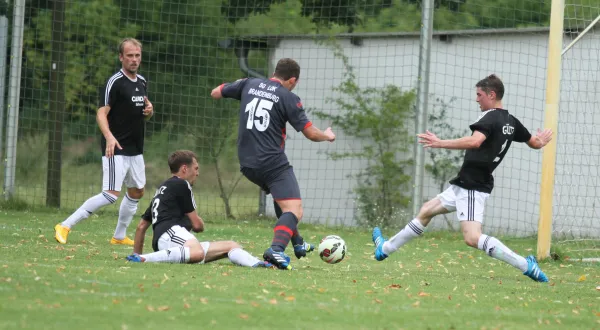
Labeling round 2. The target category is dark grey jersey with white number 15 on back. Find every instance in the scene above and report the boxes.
[221,78,312,169]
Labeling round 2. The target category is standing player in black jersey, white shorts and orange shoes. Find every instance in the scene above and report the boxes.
[54,38,154,245]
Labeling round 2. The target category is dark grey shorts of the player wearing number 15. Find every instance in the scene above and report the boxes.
[240,164,302,200]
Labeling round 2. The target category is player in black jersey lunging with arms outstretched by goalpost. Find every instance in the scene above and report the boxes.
[373,75,552,282]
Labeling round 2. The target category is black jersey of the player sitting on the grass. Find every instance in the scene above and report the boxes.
[142,176,196,251]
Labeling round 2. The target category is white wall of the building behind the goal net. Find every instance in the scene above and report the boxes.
[267,29,600,236]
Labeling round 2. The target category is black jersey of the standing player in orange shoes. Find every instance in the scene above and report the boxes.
[99,71,148,156]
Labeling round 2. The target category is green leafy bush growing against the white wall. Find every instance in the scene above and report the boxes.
[316,46,415,226]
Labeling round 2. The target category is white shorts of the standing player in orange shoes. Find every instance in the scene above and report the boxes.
[102,155,146,191]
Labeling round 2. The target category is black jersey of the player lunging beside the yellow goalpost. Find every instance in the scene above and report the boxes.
[450,109,531,193]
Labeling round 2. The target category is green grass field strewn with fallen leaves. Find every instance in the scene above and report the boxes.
[0,210,600,330]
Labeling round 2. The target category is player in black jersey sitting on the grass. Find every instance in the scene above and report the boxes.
[127,150,271,267]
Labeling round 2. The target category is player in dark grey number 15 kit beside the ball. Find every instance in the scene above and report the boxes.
[211,58,335,269]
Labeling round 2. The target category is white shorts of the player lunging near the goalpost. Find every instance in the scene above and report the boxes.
[437,184,490,222]
